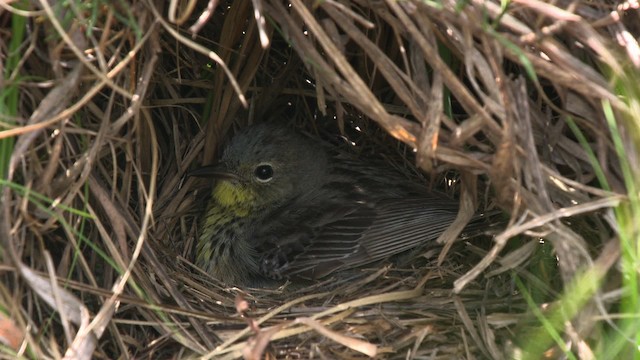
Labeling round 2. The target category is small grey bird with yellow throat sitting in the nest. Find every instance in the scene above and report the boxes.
[189,123,478,287]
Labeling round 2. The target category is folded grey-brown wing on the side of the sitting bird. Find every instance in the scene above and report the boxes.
[255,197,457,279]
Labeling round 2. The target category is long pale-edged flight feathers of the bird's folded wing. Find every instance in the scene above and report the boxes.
[270,198,457,278]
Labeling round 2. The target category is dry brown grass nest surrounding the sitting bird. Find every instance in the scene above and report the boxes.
[0,0,640,359]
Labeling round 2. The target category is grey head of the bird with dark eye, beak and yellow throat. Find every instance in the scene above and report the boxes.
[189,123,327,216]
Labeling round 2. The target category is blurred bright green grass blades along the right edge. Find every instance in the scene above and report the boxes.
[518,65,640,359]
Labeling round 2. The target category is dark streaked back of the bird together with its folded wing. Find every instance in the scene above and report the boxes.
[255,155,458,279]
